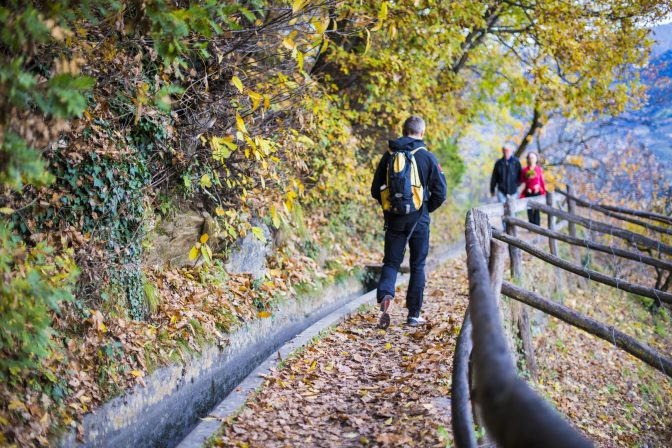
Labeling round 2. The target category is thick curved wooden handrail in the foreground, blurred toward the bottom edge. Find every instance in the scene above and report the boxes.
[465,210,593,448]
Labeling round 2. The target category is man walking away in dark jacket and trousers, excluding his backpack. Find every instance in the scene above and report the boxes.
[371,116,446,328]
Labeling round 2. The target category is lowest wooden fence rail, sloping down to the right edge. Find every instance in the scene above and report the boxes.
[502,282,672,378]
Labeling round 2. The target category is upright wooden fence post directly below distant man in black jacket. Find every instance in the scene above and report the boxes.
[504,197,537,379]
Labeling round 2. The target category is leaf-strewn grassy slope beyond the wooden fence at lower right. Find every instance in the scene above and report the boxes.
[525,254,672,447]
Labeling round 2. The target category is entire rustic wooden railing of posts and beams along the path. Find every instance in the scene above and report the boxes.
[452,188,672,448]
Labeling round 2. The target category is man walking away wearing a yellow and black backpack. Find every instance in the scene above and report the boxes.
[371,116,446,328]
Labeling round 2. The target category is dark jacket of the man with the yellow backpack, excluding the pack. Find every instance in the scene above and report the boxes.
[371,137,446,226]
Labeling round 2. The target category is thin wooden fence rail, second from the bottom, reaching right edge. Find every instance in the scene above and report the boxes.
[492,229,672,303]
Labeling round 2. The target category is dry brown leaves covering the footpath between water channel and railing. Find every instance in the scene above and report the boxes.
[210,261,467,447]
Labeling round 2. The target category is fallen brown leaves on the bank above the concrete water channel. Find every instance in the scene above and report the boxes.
[0,233,378,446]
